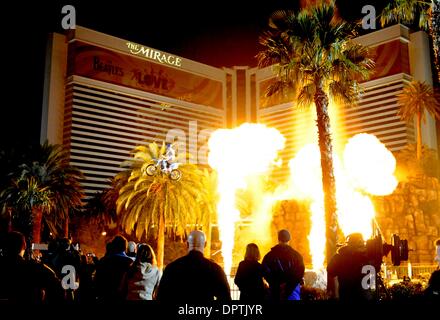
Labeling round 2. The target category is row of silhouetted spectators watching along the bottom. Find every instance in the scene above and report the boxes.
[0,230,440,303]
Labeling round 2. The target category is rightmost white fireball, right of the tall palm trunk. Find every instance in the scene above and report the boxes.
[336,133,398,239]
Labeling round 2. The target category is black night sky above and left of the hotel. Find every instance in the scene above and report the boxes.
[0,0,386,148]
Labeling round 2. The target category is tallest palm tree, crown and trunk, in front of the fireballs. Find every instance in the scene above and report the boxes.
[257,2,374,261]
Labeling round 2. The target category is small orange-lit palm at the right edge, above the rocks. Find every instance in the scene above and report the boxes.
[397,81,440,161]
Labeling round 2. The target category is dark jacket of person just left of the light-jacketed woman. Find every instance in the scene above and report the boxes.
[95,254,133,301]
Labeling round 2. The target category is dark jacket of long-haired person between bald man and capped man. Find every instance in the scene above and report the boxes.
[234,260,265,302]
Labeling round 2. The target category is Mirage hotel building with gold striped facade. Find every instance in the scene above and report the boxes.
[41,25,438,196]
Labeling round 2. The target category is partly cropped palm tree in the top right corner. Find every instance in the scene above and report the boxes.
[380,0,440,80]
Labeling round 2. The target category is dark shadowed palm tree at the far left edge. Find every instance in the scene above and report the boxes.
[0,142,84,243]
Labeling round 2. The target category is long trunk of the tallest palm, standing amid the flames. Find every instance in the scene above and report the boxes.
[314,85,337,263]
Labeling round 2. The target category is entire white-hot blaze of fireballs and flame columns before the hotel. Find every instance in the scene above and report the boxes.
[208,118,397,282]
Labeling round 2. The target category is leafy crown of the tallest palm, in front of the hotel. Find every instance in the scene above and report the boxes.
[258,2,374,111]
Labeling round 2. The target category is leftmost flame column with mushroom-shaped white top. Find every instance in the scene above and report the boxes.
[208,123,285,274]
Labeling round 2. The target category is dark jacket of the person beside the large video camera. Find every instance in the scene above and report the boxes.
[327,246,370,300]
